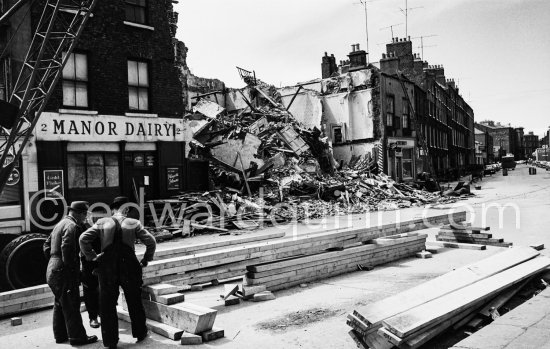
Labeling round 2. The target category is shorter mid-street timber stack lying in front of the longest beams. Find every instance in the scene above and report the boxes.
[245,233,427,291]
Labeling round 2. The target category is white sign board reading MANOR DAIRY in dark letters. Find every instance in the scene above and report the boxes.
[35,113,185,142]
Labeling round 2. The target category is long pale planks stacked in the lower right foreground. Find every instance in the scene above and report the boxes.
[347,247,550,349]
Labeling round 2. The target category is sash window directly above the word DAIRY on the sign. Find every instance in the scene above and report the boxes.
[128,61,149,111]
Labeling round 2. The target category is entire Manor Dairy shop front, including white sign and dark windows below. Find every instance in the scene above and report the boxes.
[36,113,189,209]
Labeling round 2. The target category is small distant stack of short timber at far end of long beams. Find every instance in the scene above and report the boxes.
[436,224,513,247]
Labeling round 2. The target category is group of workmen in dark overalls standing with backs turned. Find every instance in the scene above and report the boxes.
[44,197,156,349]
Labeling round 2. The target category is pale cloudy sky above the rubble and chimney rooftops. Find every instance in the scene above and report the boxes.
[175,0,550,135]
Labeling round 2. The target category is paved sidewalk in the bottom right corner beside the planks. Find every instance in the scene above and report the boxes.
[452,288,550,349]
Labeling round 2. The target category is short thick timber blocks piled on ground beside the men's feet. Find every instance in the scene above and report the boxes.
[117,284,223,344]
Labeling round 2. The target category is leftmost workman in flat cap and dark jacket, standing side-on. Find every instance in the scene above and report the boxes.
[44,201,97,345]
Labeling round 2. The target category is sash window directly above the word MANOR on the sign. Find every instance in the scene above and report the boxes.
[63,53,88,108]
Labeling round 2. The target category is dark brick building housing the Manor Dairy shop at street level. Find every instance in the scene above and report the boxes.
[0,0,190,231]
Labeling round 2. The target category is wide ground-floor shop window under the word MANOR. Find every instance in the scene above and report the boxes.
[67,153,119,189]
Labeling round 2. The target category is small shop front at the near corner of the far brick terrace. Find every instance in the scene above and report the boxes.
[387,137,416,182]
